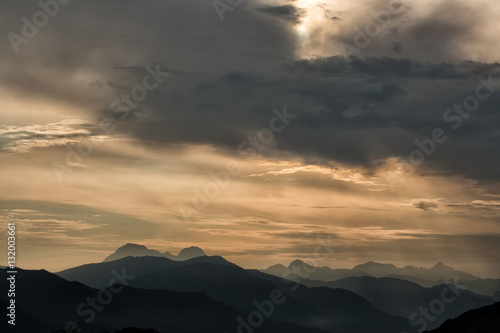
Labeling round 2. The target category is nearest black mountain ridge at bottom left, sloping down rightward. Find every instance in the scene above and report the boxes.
[0,269,324,333]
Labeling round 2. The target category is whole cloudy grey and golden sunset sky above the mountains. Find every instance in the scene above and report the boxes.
[0,0,500,278]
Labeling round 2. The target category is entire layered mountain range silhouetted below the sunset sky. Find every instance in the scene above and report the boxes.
[4,243,500,333]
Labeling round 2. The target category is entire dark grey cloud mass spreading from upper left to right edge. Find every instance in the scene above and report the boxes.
[0,0,500,180]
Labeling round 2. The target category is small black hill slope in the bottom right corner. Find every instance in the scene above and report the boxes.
[431,302,500,333]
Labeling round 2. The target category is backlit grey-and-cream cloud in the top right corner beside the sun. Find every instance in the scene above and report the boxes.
[328,0,498,62]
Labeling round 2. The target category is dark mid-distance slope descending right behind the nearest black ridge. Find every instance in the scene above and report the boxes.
[131,263,406,333]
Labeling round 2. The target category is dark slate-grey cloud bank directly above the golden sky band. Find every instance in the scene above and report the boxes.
[114,58,499,182]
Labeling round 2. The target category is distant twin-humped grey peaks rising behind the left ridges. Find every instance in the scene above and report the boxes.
[104,243,206,262]
